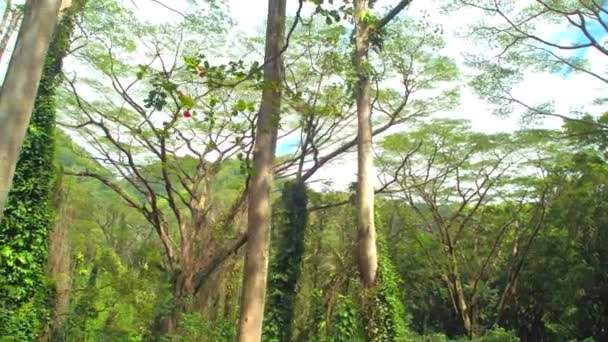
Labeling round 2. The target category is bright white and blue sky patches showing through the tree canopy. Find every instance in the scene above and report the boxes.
[0,0,608,188]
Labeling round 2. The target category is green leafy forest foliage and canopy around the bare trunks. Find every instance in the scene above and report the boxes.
[0,0,608,342]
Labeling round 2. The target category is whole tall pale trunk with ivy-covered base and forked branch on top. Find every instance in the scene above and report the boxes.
[353,0,411,341]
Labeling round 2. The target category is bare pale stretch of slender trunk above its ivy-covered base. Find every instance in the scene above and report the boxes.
[354,0,378,288]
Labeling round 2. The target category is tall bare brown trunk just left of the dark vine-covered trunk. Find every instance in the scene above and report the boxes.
[238,0,286,342]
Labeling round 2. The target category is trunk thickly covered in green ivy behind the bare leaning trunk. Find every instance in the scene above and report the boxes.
[0,0,84,341]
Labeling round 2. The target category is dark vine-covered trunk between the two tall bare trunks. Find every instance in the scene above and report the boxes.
[264,180,308,341]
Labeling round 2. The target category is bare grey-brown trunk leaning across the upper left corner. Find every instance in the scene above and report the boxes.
[0,0,61,221]
